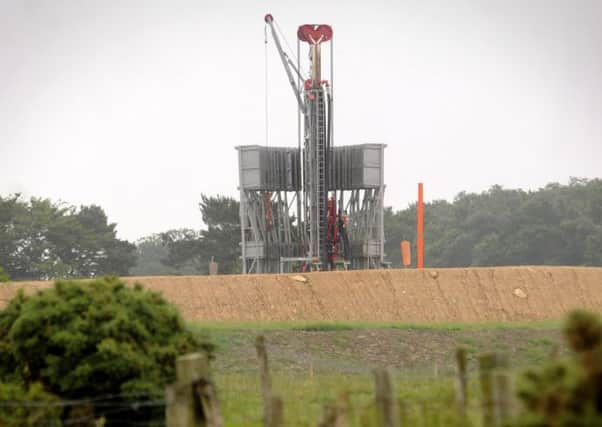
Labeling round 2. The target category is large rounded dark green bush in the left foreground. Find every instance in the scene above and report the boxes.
[0,278,209,425]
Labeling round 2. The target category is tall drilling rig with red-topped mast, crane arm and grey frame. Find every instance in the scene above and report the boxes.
[236,14,385,273]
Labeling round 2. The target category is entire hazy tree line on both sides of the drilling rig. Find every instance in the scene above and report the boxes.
[0,178,602,280]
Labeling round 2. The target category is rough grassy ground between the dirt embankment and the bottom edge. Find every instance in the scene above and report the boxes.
[191,322,566,426]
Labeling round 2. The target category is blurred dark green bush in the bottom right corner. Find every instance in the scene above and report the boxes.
[513,310,602,427]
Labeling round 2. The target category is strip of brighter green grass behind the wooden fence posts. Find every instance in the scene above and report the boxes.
[215,372,481,427]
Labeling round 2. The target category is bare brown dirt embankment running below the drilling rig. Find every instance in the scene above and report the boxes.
[0,267,602,322]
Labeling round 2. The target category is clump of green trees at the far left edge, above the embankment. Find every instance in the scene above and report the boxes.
[0,195,136,280]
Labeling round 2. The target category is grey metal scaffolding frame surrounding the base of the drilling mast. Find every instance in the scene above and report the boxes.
[236,144,386,274]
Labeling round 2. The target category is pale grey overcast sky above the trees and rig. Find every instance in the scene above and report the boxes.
[0,0,602,240]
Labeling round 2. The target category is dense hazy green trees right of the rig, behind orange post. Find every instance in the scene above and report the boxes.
[385,178,602,267]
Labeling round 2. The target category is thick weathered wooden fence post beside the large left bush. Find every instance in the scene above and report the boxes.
[165,353,209,427]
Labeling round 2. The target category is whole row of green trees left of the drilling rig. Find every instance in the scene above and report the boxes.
[0,194,240,281]
